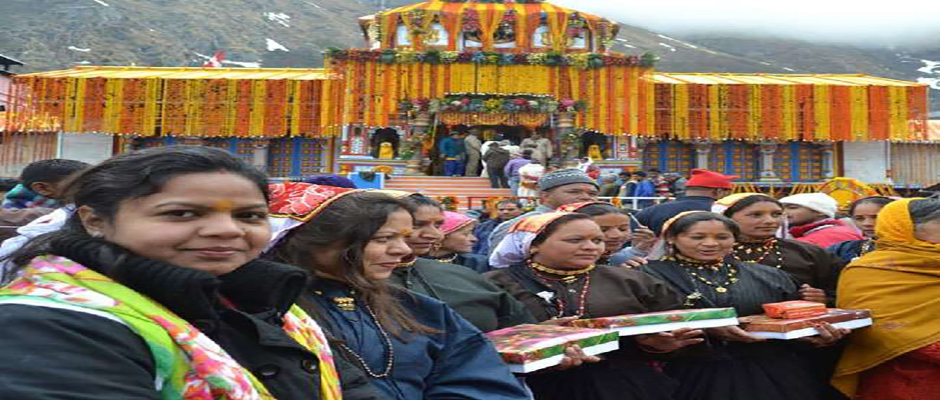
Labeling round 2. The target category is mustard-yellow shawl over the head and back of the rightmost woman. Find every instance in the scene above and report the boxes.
[832,199,940,397]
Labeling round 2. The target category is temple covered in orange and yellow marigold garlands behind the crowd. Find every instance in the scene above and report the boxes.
[0,0,940,187]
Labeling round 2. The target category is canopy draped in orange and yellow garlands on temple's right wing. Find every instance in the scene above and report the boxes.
[652,73,929,141]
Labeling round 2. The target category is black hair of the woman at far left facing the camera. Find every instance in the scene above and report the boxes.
[7,146,268,277]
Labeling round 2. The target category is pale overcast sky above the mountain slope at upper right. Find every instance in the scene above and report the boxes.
[552,0,940,46]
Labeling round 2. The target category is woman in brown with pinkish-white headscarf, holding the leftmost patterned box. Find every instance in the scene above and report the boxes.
[487,212,702,400]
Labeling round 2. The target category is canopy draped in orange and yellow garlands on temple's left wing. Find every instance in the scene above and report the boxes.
[5,67,342,137]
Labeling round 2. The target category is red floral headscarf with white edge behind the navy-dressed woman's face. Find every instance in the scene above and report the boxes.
[265,182,363,251]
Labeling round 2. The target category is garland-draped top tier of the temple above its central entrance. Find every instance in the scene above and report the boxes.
[359,0,619,53]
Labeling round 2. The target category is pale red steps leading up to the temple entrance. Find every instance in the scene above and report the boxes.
[385,175,512,211]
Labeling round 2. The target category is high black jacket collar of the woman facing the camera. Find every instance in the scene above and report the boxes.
[50,238,307,321]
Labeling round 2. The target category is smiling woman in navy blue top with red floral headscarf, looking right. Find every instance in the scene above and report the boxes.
[270,182,526,400]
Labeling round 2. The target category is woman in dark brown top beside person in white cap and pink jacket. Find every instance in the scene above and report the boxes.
[712,193,845,304]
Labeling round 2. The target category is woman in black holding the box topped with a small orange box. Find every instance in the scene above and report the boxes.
[641,211,847,400]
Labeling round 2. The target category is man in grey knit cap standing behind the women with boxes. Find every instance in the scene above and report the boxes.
[490,169,600,252]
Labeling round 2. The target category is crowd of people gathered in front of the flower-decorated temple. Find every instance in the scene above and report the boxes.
[0,147,940,400]
